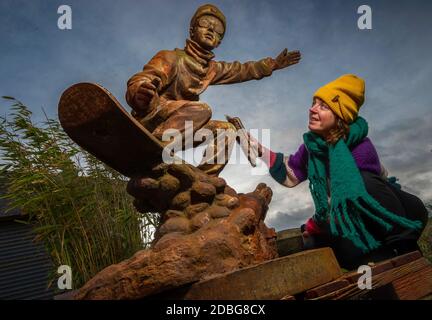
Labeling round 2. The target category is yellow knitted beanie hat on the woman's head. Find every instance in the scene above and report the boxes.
[314,74,365,124]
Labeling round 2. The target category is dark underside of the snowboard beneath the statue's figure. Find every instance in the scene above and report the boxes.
[58,83,163,178]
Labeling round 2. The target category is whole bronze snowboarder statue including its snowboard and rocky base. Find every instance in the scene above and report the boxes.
[59,4,300,299]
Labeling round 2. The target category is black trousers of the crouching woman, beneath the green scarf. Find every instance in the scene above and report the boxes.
[314,171,428,269]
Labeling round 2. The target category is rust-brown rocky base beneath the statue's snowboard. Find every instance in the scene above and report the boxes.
[70,164,278,299]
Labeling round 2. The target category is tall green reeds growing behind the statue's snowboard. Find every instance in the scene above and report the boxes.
[0,97,157,288]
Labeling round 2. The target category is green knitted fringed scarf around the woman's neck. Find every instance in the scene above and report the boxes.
[303,117,422,253]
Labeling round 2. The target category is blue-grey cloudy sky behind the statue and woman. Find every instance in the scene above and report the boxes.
[0,0,432,230]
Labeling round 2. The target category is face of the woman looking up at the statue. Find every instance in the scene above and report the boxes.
[308,98,337,138]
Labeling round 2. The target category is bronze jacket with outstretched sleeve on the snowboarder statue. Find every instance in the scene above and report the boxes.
[126,39,275,135]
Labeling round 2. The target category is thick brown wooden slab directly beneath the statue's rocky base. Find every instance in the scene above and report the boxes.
[177,248,342,300]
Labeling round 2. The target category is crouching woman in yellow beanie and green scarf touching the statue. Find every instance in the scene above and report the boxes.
[251,74,427,269]
